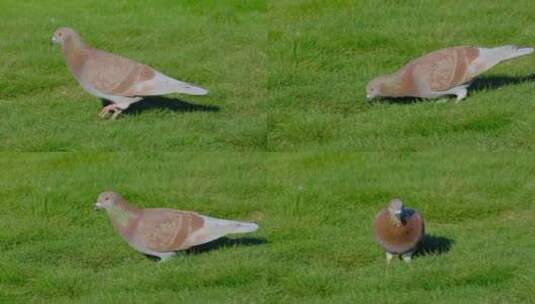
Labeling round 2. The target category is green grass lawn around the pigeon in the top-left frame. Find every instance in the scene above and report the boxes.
[0,0,266,151]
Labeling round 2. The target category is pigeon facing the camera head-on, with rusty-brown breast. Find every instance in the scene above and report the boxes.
[374,198,425,263]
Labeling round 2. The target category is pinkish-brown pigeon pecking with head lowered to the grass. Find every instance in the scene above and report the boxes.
[366,45,533,102]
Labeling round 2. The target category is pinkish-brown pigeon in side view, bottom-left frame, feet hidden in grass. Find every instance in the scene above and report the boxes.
[95,191,258,262]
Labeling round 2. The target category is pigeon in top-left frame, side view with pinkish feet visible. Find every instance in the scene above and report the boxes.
[52,27,208,119]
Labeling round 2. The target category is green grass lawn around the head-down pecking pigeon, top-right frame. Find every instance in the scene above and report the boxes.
[268,0,535,151]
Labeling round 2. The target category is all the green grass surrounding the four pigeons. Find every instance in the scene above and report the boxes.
[0,0,535,303]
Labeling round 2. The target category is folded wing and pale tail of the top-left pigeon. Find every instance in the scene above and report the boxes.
[81,49,207,97]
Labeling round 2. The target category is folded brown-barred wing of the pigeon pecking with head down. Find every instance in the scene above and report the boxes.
[407,46,479,91]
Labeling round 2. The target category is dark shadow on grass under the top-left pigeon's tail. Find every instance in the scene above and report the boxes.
[102,96,220,115]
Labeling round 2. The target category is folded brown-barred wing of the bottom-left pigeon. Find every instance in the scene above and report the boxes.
[133,208,205,252]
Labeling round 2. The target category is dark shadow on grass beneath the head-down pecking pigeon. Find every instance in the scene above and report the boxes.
[370,74,535,104]
